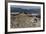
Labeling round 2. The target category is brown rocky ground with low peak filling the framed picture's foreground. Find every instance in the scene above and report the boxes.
[11,13,40,28]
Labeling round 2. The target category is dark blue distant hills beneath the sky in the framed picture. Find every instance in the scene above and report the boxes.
[11,7,40,14]
